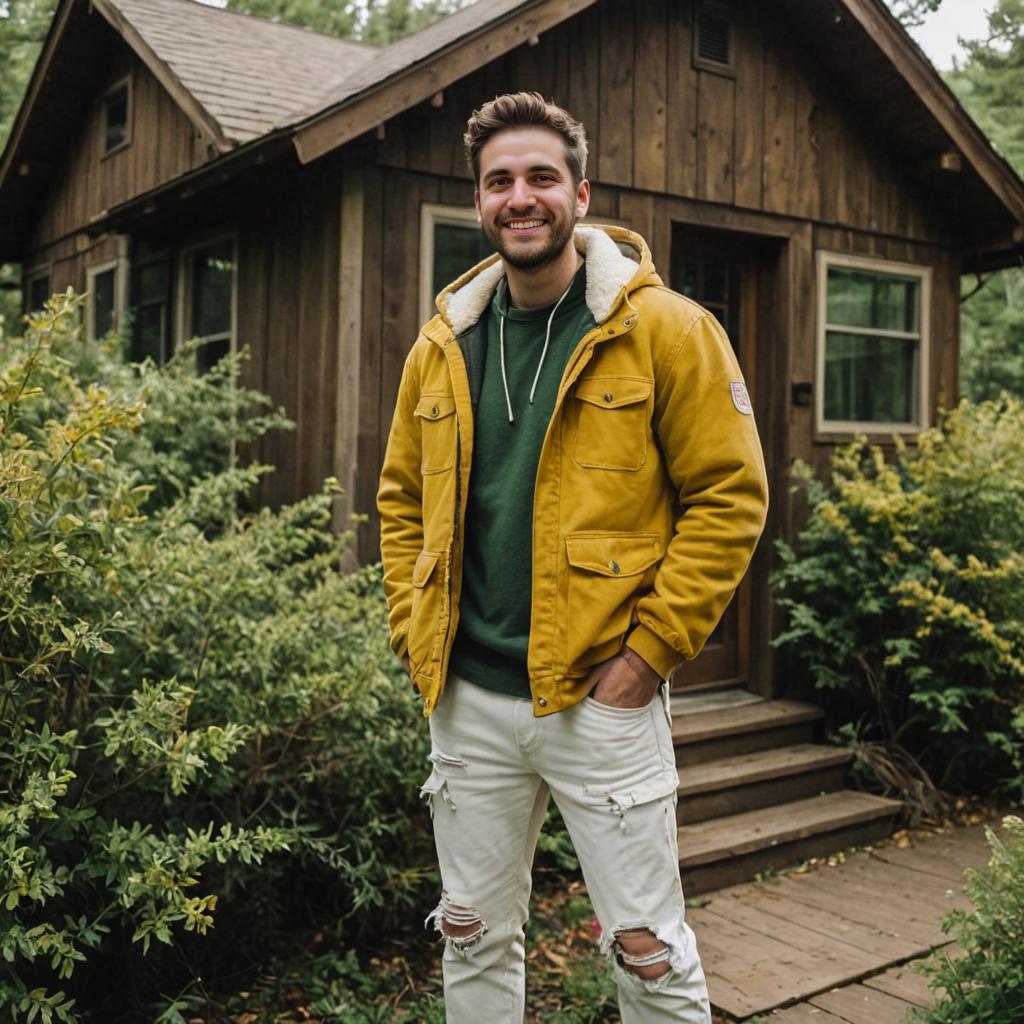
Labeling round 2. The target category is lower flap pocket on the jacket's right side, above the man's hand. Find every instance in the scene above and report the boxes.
[565,530,664,666]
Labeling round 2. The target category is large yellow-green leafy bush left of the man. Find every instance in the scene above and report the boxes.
[0,293,434,1024]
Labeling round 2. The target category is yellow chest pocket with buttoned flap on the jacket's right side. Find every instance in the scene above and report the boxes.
[573,377,653,472]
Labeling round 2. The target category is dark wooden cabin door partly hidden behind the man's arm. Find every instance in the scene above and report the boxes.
[669,224,759,690]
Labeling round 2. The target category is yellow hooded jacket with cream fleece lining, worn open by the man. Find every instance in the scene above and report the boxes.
[377,226,768,715]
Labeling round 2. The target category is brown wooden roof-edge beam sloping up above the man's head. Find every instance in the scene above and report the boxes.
[292,0,595,164]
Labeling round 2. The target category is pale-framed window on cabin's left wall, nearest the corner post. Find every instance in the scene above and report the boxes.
[178,238,236,373]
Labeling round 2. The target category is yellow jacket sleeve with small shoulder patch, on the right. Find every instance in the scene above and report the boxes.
[627,312,768,678]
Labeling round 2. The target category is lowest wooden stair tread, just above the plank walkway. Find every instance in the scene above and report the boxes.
[677,790,902,868]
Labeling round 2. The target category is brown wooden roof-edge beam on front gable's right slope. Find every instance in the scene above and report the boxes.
[843,0,1024,223]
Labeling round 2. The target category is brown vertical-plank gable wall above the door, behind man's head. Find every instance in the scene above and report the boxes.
[378,0,949,244]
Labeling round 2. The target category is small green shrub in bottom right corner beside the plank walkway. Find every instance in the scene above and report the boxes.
[913,817,1024,1024]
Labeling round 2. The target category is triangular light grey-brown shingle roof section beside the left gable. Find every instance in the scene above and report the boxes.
[110,0,379,143]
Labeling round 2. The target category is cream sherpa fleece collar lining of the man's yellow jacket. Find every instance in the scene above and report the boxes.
[437,227,641,335]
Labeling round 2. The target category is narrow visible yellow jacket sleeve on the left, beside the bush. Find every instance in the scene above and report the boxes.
[377,347,423,657]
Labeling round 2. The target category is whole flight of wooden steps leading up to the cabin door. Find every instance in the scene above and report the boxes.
[672,699,901,895]
